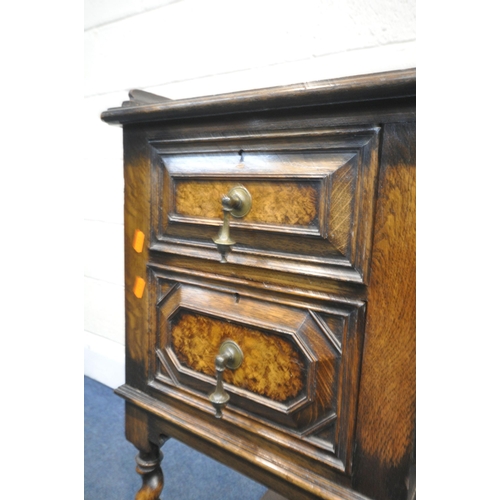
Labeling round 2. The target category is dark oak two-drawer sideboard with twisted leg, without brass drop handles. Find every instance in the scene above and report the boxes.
[102,70,416,500]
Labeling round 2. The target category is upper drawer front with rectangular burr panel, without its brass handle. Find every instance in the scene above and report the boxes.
[151,128,378,283]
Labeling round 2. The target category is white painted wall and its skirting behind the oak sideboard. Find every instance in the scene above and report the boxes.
[83,0,416,387]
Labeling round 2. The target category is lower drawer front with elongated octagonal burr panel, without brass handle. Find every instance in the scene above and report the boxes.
[151,269,364,469]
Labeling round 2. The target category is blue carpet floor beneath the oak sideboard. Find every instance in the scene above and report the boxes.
[85,377,267,500]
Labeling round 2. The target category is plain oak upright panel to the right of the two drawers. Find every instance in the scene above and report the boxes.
[353,123,416,500]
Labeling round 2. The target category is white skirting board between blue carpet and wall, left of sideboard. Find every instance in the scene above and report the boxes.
[83,331,125,389]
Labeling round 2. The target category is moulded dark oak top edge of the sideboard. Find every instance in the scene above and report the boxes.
[101,69,416,124]
